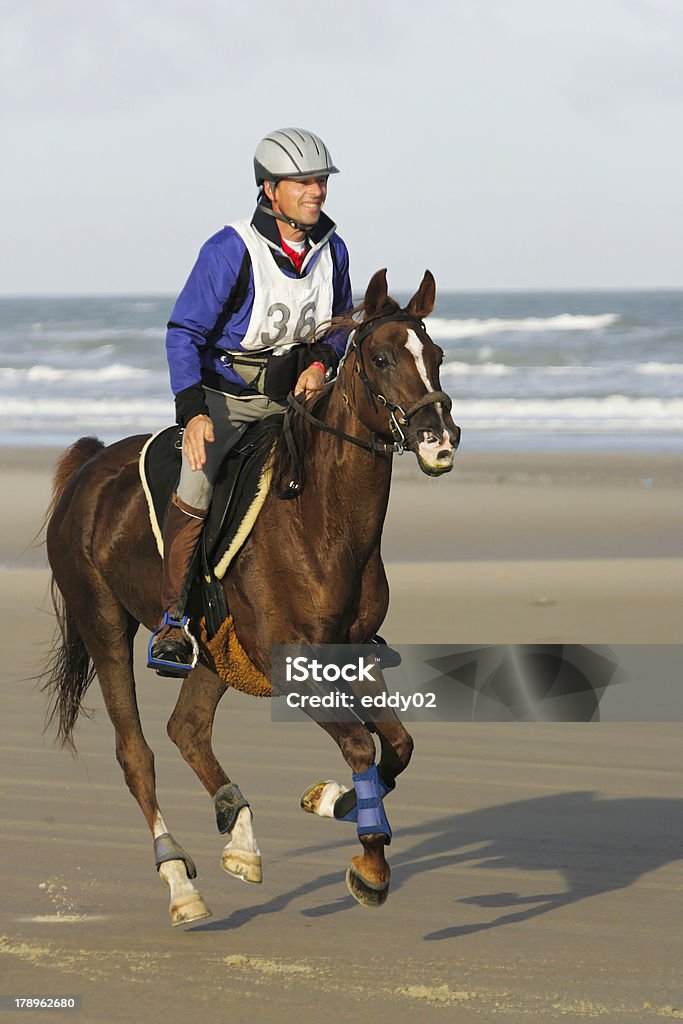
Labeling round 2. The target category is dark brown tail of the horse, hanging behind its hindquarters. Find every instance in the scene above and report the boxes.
[39,437,104,753]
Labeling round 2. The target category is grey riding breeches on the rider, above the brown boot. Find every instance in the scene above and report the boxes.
[177,387,286,509]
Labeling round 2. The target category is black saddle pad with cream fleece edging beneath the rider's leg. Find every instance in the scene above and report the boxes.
[139,416,282,580]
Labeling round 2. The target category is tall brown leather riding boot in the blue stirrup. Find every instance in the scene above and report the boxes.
[150,495,207,676]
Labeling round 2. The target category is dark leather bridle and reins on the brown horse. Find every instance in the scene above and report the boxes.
[284,310,453,498]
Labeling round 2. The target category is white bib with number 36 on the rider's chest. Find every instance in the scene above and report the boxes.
[229,220,333,352]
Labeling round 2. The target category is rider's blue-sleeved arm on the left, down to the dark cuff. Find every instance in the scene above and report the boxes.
[166,228,245,426]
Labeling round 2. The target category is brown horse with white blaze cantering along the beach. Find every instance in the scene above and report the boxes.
[44,270,460,925]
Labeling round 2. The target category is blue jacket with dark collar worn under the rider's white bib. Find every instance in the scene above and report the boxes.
[166,199,352,425]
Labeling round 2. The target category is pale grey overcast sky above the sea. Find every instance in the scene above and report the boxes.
[0,0,683,295]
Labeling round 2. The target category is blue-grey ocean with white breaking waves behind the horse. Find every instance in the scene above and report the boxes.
[0,291,683,453]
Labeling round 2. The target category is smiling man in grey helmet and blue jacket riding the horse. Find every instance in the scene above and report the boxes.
[150,128,352,675]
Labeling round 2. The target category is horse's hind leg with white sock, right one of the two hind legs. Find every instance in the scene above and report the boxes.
[168,665,263,882]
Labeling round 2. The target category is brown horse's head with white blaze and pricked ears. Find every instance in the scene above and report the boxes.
[347,270,460,476]
